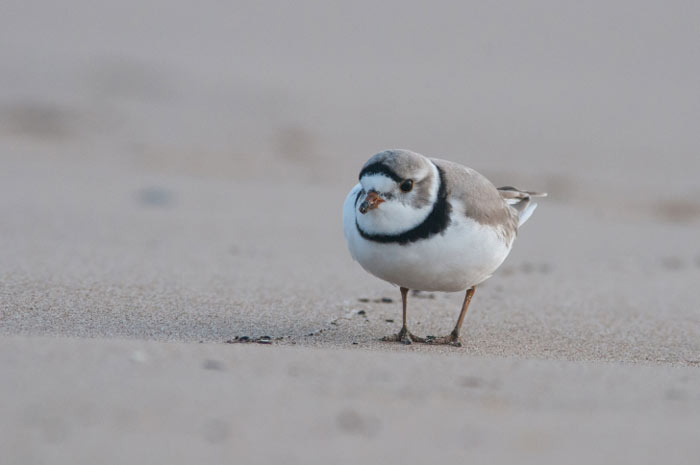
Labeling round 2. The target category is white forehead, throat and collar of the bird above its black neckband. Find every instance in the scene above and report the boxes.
[355,162,440,235]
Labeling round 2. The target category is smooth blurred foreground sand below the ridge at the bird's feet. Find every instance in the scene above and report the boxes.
[0,337,700,464]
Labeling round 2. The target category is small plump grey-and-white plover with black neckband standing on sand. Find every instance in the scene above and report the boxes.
[343,149,547,346]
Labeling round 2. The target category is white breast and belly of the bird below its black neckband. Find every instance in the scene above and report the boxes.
[343,184,512,292]
